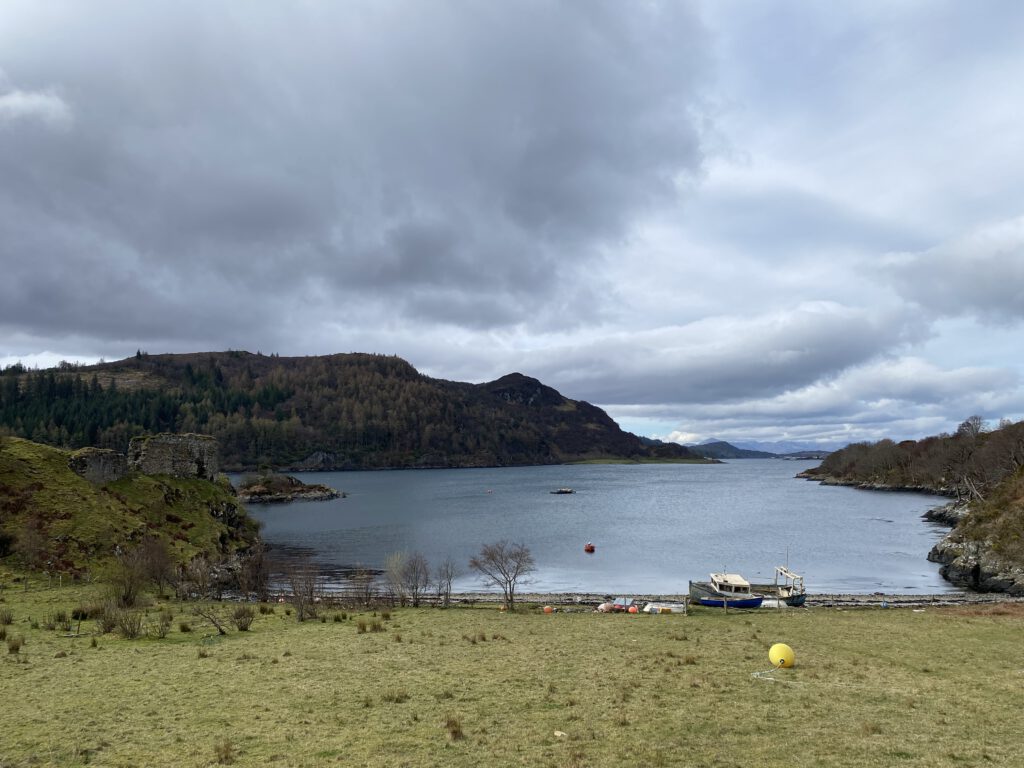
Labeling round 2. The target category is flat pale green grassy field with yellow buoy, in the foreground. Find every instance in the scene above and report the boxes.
[0,581,1024,768]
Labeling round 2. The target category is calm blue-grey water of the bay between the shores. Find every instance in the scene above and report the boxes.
[237,460,951,594]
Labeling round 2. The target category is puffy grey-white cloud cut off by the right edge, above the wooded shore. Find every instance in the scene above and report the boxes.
[884,216,1024,323]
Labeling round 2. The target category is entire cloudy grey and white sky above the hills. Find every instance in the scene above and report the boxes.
[0,0,1024,447]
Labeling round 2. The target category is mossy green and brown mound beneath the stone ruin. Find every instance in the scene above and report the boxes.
[0,437,257,573]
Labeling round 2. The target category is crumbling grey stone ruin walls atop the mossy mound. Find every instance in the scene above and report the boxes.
[68,434,220,483]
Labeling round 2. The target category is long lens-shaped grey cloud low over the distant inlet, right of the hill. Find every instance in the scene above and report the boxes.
[540,302,924,403]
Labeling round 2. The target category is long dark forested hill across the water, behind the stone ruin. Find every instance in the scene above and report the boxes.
[0,351,699,470]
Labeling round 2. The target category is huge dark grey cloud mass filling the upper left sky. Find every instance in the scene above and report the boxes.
[0,1,707,346]
